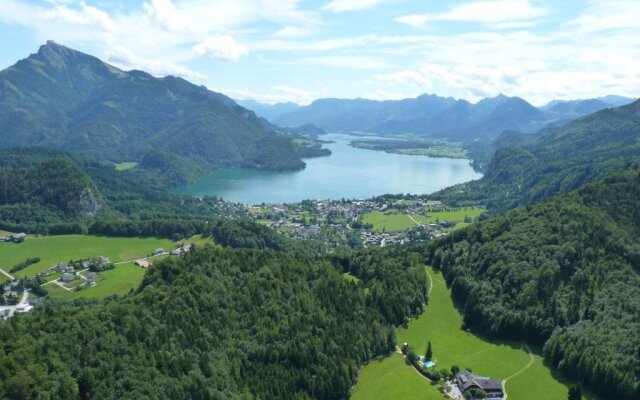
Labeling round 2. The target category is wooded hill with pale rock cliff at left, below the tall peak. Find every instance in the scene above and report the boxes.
[0,147,250,239]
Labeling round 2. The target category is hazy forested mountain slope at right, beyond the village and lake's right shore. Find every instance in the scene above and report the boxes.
[433,100,640,210]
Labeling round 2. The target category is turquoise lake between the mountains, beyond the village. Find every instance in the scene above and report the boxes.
[175,134,482,204]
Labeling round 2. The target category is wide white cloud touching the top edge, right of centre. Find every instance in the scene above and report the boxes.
[395,0,547,28]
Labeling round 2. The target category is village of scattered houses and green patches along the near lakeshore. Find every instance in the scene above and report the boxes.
[249,198,480,248]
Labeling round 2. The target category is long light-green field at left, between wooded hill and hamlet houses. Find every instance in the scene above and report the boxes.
[0,235,173,277]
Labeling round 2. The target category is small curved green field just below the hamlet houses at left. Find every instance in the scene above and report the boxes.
[45,263,146,300]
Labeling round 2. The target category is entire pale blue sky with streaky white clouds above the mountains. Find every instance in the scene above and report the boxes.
[0,0,640,105]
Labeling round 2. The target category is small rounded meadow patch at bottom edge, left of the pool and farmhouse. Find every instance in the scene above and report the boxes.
[351,353,445,400]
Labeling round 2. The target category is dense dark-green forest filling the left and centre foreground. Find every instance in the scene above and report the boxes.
[0,245,427,400]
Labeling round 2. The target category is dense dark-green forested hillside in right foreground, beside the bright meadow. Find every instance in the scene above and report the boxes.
[426,167,640,400]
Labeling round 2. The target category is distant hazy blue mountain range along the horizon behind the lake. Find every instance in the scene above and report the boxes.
[242,94,633,143]
